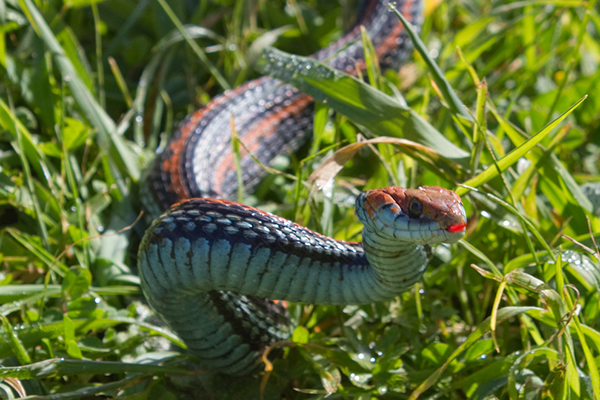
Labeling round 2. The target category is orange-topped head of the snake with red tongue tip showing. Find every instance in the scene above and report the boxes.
[356,186,467,245]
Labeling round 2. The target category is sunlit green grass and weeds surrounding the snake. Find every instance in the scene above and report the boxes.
[0,0,600,400]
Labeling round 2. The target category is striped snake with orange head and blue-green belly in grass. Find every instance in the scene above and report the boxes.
[138,0,467,375]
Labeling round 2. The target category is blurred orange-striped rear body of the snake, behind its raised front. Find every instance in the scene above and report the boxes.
[141,0,421,216]
